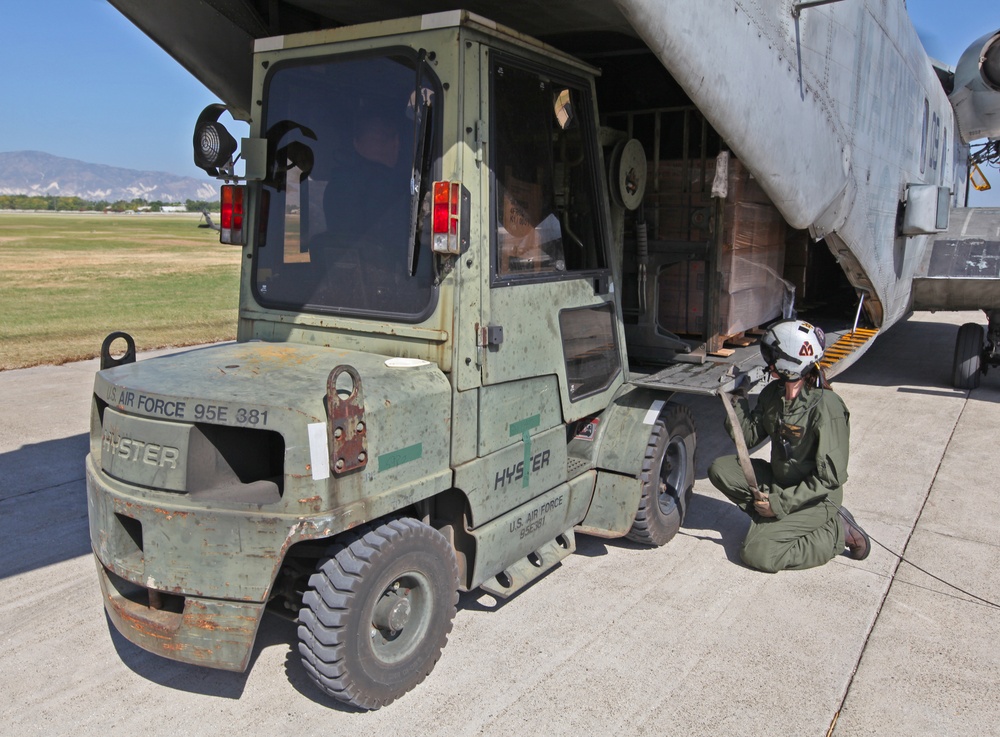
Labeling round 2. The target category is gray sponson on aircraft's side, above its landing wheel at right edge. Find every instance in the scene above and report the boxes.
[913,207,1000,310]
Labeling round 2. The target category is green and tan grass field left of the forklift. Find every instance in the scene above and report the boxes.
[0,211,241,370]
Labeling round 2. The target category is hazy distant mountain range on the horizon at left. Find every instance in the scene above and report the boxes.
[0,151,219,202]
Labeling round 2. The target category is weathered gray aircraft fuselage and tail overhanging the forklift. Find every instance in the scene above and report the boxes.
[109,0,1000,371]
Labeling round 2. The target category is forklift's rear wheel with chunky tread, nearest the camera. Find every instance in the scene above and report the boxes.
[299,518,458,709]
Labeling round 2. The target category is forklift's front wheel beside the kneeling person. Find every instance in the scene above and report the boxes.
[627,405,695,546]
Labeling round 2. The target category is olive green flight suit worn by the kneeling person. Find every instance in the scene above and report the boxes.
[708,381,850,573]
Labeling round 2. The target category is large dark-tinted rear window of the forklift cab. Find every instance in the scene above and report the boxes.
[253,49,441,322]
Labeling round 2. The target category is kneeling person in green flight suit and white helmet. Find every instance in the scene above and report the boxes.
[708,320,870,572]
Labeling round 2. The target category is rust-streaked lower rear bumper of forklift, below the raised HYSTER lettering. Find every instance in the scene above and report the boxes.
[86,457,294,671]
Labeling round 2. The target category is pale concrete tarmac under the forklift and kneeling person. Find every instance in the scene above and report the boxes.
[0,313,1000,737]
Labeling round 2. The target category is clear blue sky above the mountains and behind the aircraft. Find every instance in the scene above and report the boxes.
[0,0,1000,201]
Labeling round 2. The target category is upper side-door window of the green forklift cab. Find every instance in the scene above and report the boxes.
[490,55,607,285]
